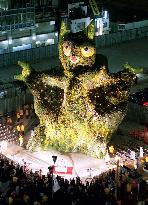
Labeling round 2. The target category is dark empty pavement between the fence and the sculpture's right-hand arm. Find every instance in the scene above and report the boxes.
[99,37,148,72]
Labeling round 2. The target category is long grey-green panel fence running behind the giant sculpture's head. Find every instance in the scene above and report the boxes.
[0,27,148,67]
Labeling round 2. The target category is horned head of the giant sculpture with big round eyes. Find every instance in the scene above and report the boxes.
[59,22,96,72]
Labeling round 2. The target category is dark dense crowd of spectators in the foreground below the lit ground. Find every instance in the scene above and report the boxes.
[0,155,148,205]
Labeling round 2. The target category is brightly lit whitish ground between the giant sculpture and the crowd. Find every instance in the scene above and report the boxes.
[1,144,108,178]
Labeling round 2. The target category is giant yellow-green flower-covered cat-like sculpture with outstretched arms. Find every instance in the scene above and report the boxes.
[15,23,134,157]
